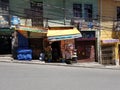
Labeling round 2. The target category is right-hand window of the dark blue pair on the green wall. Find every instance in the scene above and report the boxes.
[84,4,93,19]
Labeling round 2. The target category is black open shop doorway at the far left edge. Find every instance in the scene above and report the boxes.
[0,35,11,55]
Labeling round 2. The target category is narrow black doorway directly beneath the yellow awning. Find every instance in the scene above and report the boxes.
[51,41,61,62]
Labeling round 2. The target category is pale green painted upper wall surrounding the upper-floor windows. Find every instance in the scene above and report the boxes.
[10,0,98,25]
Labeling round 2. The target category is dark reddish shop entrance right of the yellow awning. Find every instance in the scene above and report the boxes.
[76,41,95,62]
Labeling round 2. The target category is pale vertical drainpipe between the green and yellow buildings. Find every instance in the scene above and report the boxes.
[97,0,102,64]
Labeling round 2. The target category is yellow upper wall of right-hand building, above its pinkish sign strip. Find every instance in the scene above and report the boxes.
[98,0,120,39]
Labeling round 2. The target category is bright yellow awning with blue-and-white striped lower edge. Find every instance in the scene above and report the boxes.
[47,28,82,41]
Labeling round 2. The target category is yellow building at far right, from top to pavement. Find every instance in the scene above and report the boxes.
[99,0,120,65]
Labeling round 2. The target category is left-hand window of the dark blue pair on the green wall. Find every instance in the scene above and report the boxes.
[73,4,82,17]
